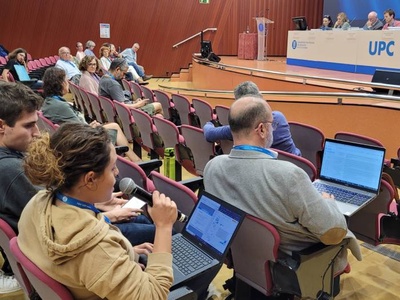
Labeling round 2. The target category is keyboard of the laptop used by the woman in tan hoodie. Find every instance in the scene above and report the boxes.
[172,236,213,275]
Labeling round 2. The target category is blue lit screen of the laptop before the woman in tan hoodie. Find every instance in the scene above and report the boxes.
[186,194,241,255]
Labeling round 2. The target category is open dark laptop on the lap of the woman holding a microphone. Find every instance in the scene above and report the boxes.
[172,192,246,287]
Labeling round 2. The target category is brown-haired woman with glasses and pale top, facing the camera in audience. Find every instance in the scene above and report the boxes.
[79,56,100,95]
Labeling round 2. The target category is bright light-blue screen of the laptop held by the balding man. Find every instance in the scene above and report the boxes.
[320,139,385,193]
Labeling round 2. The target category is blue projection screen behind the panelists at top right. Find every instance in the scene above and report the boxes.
[321,0,400,27]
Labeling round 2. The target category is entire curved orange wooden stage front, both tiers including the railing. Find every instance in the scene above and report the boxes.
[155,56,400,158]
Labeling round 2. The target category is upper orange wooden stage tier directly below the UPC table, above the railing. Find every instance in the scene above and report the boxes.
[161,56,380,92]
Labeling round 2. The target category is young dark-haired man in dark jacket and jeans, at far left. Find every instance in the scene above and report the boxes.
[0,79,155,251]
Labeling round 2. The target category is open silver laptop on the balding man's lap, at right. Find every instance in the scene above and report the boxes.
[313,139,385,216]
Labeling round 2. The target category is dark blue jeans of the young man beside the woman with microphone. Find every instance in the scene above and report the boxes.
[113,215,156,246]
